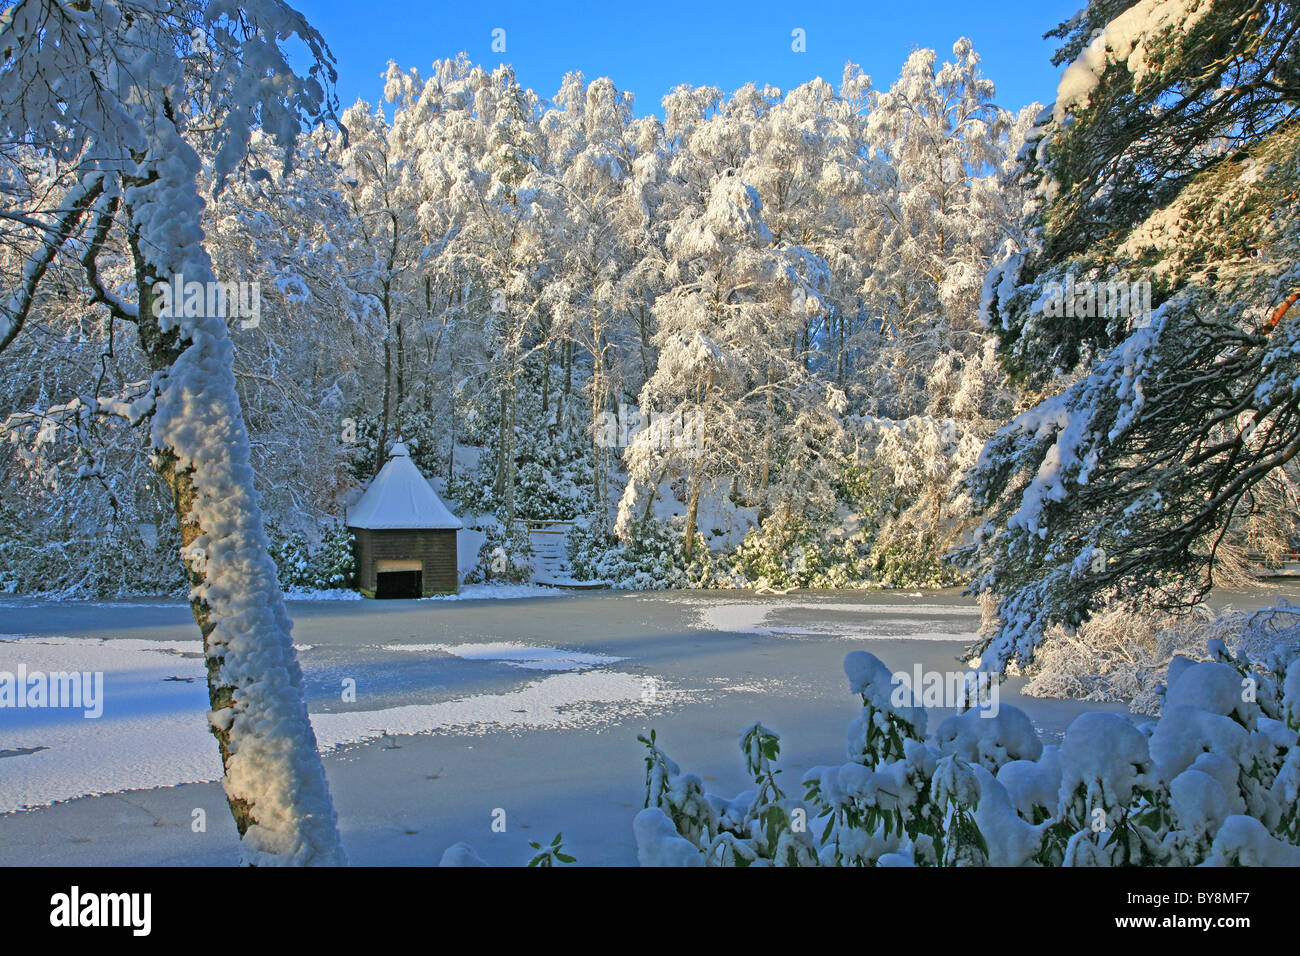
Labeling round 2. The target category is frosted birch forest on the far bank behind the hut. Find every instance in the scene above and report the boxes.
[0,40,1040,594]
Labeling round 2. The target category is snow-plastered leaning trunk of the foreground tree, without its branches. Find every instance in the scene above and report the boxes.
[127,174,346,865]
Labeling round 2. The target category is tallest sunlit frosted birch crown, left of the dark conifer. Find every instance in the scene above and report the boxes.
[863,39,1018,418]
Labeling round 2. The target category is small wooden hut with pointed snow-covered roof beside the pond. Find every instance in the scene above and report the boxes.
[347,441,463,598]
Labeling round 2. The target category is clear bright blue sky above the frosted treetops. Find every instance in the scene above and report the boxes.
[290,0,1084,116]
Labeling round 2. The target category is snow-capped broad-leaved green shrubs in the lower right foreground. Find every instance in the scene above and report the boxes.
[633,621,1300,866]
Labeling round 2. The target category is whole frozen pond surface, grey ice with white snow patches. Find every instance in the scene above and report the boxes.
[0,589,1294,864]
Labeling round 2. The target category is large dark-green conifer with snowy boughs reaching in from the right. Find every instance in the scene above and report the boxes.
[961,0,1300,670]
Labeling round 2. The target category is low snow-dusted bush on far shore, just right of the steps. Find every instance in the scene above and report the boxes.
[568,518,712,591]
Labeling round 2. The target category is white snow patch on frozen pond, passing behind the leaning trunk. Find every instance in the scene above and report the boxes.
[0,637,677,813]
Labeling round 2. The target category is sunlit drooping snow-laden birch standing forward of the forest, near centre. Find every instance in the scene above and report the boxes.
[619,163,822,561]
